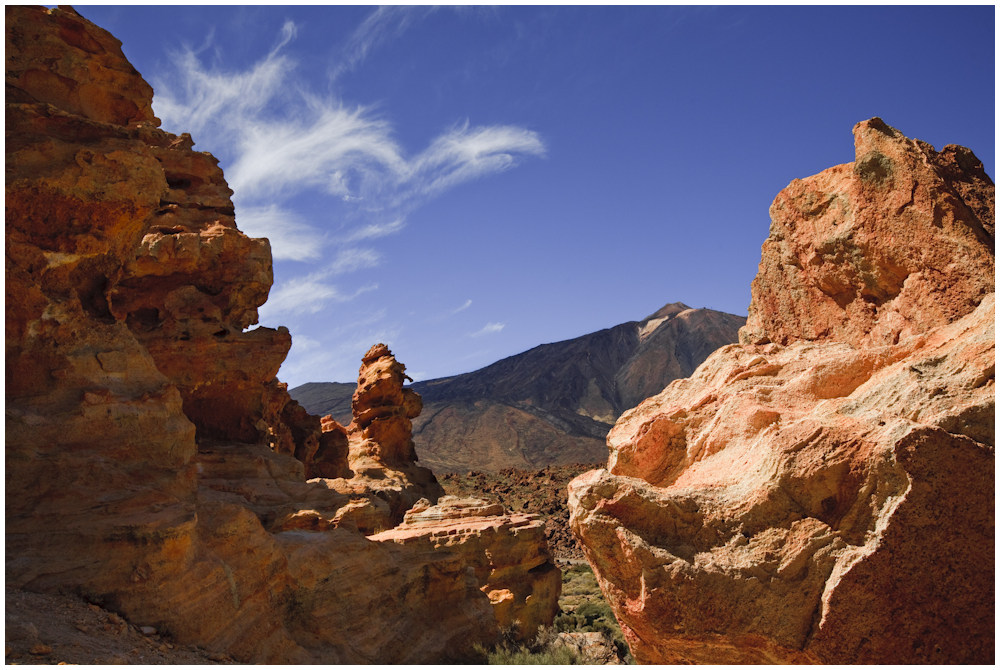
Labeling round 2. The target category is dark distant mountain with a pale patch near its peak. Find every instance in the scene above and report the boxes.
[291,303,746,472]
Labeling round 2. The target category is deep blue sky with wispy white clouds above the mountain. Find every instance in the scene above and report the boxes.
[77,5,995,387]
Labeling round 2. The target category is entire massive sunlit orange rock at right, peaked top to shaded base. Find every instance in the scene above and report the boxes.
[569,119,995,663]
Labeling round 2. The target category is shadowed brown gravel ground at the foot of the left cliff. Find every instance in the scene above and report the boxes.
[4,588,229,665]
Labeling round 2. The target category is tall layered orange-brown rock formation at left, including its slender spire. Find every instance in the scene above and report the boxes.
[5,6,558,663]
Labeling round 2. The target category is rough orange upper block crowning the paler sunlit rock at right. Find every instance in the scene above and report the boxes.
[740,118,995,345]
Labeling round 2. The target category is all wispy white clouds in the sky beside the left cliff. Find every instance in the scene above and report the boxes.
[153,7,546,388]
